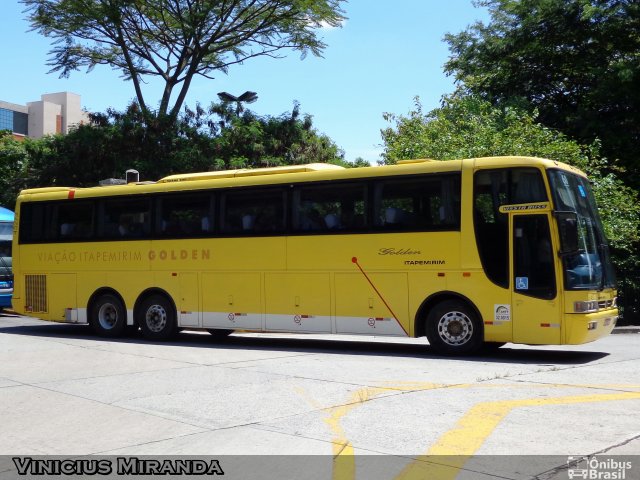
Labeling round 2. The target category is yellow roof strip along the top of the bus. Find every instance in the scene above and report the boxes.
[19,157,585,201]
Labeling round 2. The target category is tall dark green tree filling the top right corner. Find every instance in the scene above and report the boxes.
[445,0,640,187]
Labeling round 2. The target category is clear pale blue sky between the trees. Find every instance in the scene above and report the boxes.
[0,0,487,164]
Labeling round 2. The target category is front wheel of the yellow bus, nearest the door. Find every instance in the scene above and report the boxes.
[426,300,483,355]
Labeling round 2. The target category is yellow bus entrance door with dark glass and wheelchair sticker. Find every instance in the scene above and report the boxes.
[509,209,561,344]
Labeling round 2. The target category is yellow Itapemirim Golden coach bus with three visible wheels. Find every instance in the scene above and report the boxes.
[13,157,618,354]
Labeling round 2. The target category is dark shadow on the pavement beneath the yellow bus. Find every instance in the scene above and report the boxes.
[0,323,609,366]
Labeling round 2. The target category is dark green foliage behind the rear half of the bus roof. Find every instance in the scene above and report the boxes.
[0,99,356,208]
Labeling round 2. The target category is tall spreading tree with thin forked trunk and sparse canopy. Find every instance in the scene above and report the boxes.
[22,0,345,120]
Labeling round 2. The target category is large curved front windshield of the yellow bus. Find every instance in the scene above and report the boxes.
[549,170,615,290]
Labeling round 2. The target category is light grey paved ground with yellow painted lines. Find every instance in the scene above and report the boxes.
[0,315,640,480]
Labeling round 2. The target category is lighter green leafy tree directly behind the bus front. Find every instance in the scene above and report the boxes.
[382,95,640,270]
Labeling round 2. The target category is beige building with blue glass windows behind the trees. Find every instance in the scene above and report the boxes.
[0,92,89,138]
